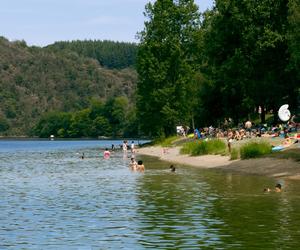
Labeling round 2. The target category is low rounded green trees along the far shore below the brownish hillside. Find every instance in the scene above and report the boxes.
[33,97,139,138]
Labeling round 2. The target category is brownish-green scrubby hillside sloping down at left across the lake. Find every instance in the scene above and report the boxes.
[0,37,137,136]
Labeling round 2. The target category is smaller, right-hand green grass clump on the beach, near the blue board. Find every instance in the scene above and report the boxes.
[240,142,272,160]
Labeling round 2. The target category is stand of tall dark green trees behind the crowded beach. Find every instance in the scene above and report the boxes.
[137,0,300,136]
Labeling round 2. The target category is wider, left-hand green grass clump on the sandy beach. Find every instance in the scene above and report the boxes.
[180,139,226,156]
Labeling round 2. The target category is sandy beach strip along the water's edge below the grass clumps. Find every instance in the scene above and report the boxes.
[136,146,300,180]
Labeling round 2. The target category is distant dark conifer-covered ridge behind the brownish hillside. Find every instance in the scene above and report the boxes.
[47,40,137,69]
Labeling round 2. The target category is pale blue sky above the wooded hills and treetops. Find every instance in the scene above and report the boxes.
[0,0,213,46]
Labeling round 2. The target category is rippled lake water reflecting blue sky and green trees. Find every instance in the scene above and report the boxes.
[0,140,300,250]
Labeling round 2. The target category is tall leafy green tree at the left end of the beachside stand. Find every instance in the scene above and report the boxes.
[137,0,199,136]
